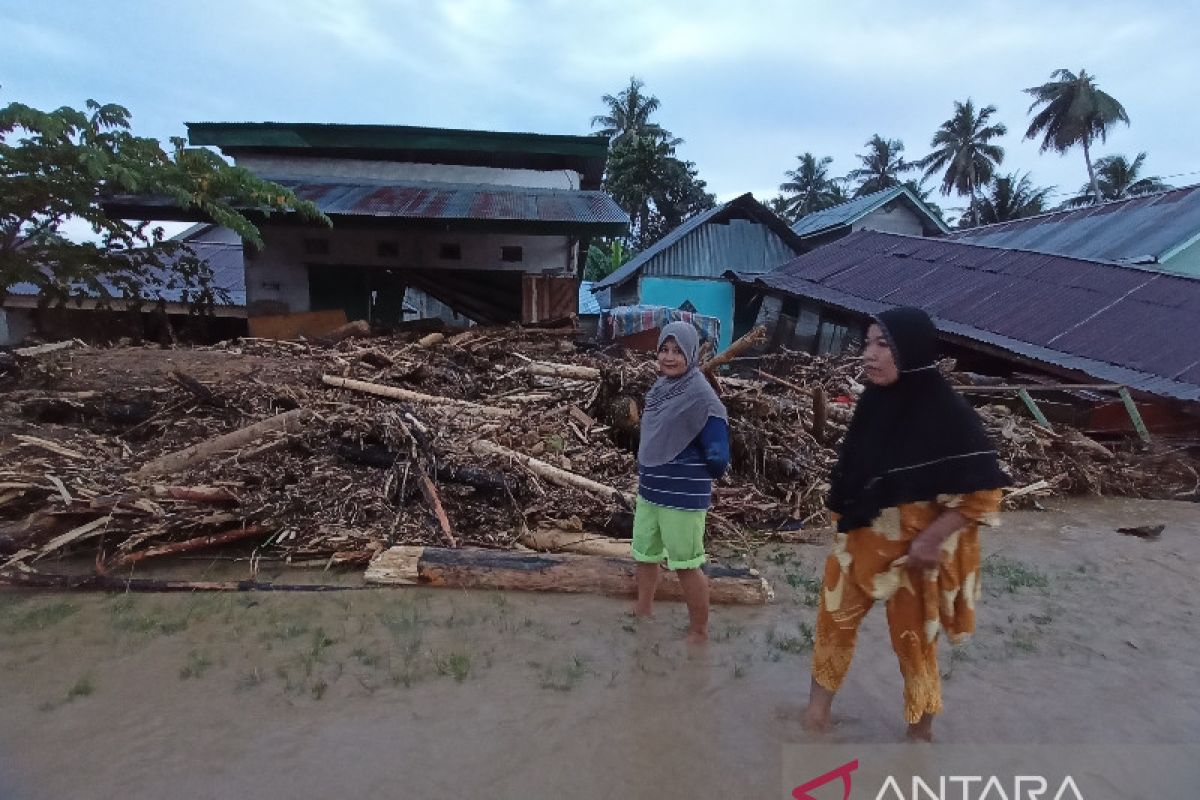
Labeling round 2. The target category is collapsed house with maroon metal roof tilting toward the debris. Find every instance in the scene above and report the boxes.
[728,230,1200,429]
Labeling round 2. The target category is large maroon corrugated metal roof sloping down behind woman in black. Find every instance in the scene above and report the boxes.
[734,230,1200,402]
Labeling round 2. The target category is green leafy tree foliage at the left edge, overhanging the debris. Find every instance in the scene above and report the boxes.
[0,100,330,309]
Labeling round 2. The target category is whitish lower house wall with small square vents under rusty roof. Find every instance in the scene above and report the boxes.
[246,225,575,314]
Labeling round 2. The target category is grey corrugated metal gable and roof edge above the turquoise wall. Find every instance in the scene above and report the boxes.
[592,193,803,291]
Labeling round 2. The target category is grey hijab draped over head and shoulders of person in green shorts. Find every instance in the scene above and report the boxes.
[637,323,728,467]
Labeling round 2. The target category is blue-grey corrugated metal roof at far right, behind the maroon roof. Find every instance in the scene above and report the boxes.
[950,186,1200,263]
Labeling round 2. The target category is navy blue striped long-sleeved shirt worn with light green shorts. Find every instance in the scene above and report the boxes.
[637,417,730,511]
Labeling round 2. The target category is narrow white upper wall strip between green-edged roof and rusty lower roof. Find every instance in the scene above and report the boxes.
[235,155,580,190]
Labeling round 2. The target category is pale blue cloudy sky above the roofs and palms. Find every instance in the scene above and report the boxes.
[0,0,1200,221]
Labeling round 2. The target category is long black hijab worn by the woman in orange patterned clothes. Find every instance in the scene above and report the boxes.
[827,308,1012,531]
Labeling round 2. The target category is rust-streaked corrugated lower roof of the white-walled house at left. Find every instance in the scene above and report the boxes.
[268,178,629,225]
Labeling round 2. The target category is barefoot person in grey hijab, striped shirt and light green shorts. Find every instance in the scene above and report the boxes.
[632,323,730,643]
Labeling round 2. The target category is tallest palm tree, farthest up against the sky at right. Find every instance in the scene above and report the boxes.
[1025,70,1129,203]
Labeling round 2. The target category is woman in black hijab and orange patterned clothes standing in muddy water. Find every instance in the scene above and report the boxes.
[804,308,1009,740]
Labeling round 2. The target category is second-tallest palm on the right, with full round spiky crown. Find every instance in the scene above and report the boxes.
[917,97,1008,223]
